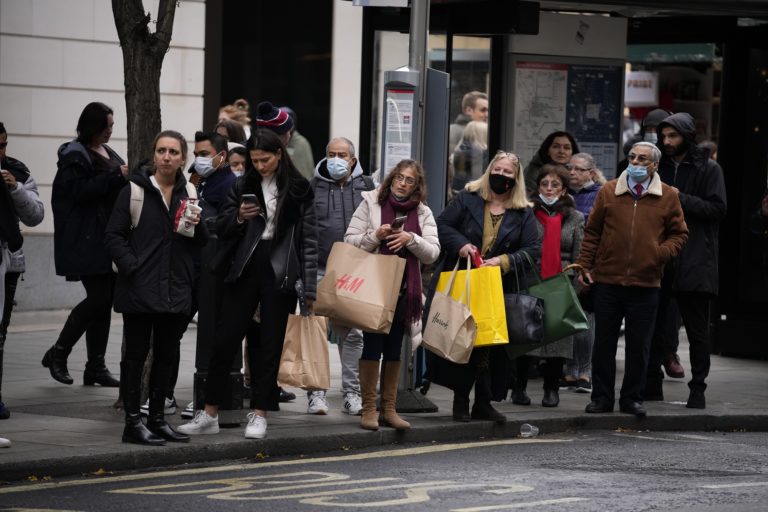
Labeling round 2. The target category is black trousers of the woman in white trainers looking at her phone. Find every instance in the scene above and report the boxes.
[205,240,296,411]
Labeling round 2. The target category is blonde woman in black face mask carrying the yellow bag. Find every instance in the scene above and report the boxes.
[427,151,541,422]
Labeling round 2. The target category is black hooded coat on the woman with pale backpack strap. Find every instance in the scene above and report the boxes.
[104,169,208,315]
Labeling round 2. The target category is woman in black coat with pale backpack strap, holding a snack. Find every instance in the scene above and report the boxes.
[105,130,208,445]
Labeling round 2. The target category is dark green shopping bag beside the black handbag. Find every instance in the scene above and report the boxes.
[525,253,589,343]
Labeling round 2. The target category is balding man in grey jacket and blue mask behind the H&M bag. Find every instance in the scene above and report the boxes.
[307,137,374,415]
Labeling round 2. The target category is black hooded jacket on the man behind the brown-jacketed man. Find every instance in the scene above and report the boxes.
[656,112,727,295]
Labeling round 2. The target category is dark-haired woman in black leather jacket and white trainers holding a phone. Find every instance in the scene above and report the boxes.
[179,129,317,439]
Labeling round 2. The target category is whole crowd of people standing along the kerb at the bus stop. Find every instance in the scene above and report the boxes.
[0,91,736,445]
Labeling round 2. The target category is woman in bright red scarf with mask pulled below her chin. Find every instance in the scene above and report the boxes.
[512,164,584,407]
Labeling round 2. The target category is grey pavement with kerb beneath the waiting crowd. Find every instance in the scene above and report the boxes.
[0,311,768,482]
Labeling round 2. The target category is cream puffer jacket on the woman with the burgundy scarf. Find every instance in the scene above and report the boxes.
[344,188,440,265]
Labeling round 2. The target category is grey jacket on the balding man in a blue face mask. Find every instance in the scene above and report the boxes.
[310,158,374,269]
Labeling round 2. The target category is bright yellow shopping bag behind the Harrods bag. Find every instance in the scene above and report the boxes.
[437,267,509,347]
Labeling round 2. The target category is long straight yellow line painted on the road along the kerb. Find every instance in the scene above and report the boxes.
[0,438,571,494]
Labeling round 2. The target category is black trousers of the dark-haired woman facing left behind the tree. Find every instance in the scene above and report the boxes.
[57,273,115,365]
